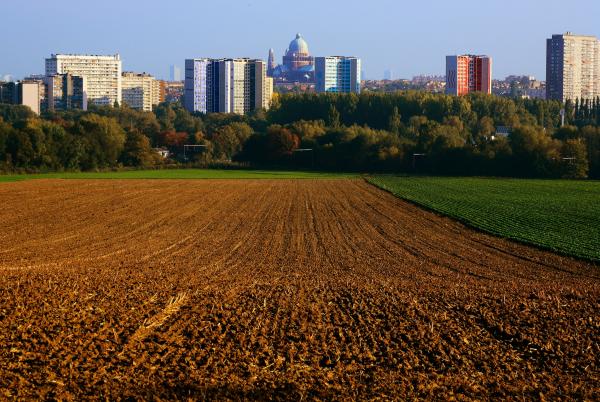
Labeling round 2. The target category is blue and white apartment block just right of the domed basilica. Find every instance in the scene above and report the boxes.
[315,56,361,93]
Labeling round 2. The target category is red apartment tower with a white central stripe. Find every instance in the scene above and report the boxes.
[446,55,492,96]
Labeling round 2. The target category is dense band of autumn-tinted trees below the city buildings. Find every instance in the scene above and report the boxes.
[0,91,600,178]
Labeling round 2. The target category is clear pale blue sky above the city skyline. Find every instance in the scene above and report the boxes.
[0,0,600,79]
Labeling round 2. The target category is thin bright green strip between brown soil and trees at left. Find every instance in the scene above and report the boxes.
[0,169,357,182]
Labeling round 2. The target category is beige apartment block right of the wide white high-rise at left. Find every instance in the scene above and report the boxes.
[121,72,160,112]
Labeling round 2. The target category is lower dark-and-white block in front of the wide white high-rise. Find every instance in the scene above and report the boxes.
[44,74,87,110]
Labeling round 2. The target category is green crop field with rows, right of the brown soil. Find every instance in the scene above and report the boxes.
[368,175,600,261]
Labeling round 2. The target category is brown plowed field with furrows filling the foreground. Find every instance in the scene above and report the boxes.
[0,180,600,400]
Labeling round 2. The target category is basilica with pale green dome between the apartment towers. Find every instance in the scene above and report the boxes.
[267,34,315,83]
